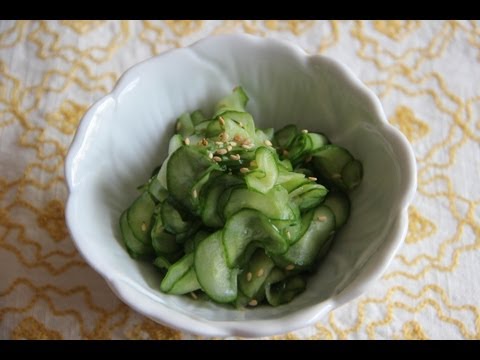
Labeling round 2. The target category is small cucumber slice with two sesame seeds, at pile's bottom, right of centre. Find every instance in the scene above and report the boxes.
[238,249,275,301]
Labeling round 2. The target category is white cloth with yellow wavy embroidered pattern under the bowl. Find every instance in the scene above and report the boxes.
[0,20,480,339]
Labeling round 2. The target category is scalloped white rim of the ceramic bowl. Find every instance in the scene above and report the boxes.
[65,34,417,337]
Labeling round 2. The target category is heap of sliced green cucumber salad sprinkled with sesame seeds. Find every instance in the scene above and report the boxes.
[120,87,363,308]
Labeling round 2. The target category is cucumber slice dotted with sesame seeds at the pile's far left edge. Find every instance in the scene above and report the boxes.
[127,192,155,244]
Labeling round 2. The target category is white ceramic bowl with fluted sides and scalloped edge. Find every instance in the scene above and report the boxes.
[65,35,416,337]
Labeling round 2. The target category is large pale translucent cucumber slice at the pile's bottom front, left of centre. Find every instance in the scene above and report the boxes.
[194,231,238,303]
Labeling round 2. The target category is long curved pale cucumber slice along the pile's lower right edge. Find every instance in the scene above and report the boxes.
[274,205,335,269]
